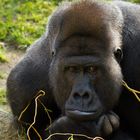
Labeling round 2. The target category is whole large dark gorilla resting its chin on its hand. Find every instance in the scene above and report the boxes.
[7,0,140,140]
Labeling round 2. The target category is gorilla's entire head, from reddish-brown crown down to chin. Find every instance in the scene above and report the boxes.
[47,1,123,120]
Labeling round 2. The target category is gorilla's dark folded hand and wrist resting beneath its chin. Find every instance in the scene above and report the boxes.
[45,112,119,140]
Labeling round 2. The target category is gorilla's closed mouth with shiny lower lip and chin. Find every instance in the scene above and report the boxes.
[66,110,100,121]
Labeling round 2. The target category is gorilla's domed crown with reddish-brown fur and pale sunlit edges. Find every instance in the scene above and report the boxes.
[48,0,122,52]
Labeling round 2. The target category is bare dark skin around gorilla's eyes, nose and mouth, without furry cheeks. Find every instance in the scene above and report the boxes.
[64,56,103,120]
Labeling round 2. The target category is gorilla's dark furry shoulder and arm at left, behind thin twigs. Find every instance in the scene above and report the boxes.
[7,35,59,132]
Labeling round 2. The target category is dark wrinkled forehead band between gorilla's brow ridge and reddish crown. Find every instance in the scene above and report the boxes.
[58,35,111,57]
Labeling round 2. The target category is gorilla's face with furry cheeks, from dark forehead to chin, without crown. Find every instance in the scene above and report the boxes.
[50,35,122,120]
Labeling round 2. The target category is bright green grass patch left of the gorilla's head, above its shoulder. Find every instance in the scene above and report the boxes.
[0,0,55,48]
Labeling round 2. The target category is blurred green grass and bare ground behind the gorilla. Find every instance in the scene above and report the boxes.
[0,0,140,110]
